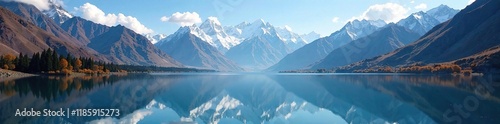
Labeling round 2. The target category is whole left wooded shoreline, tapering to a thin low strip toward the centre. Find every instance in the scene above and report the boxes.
[0,48,214,74]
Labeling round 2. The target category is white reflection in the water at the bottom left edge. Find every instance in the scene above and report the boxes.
[89,110,153,124]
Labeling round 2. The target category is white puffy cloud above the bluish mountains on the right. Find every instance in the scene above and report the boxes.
[349,3,408,22]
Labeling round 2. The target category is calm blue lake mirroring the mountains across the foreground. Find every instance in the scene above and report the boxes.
[0,73,500,124]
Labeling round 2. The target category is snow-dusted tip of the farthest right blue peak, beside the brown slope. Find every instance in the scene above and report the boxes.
[426,4,460,23]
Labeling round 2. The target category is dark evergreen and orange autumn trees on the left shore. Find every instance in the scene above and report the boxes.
[0,48,121,74]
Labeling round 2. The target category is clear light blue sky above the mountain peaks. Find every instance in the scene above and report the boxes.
[58,0,470,36]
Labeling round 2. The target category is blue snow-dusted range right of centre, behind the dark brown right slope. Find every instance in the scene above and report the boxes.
[267,5,458,71]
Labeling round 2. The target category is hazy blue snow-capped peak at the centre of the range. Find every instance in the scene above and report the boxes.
[225,19,305,70]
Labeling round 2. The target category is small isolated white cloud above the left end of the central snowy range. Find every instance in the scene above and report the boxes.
[160,12,201,26]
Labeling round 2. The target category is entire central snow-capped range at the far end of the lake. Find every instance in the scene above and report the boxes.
[156,17,312,71]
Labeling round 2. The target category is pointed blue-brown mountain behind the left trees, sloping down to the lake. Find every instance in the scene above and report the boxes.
[88,25,181,67]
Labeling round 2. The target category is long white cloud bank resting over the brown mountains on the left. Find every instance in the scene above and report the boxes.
[77,3,154,34]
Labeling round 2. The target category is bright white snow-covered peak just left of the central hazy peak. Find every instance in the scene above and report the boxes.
[199,18,240,54]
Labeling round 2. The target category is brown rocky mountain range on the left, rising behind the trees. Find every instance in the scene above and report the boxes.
[0,1,182,67]
